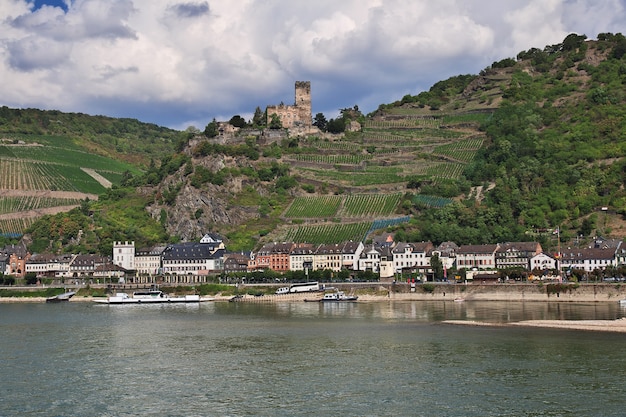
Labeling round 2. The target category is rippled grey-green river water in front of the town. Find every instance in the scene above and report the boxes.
[0,301,626,416]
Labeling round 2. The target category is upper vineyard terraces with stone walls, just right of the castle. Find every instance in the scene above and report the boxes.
[285,107,491,193]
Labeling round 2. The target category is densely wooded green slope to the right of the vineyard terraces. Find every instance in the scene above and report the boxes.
[392,34,626,247]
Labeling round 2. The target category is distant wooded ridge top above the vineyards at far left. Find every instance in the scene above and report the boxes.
[0,106,184,168]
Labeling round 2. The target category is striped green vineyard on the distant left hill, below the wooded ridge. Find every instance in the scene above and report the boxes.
[0,137,136,236]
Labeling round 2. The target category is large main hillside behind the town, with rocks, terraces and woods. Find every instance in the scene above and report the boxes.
[7,34,626,253]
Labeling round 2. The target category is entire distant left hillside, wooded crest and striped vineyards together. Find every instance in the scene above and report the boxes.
[0,107,181,236]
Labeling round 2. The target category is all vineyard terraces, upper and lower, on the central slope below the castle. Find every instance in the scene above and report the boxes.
[262,107,491,243]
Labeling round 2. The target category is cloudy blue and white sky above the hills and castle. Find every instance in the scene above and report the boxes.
[0,0,626,130]
